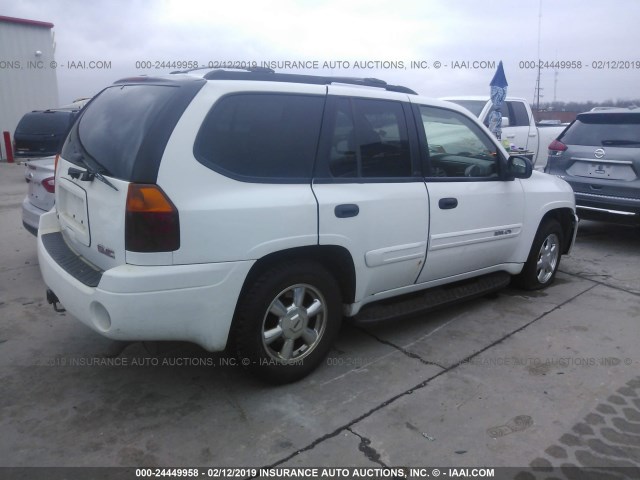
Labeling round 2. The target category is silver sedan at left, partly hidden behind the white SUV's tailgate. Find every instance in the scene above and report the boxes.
[22,157,55,235]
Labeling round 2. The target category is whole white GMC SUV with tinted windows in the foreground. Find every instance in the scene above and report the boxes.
[38,70,577,382]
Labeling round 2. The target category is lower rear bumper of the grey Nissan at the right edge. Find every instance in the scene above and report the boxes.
[576,192,640,225]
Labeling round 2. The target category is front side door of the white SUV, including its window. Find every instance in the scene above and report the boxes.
[415,101,524,282]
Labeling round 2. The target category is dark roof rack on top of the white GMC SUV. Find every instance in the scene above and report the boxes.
[171,67,417,95]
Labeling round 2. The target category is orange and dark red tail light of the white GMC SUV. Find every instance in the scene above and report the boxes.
[125,183,180,252]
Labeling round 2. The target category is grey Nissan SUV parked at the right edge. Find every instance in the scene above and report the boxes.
[545,107,640,225]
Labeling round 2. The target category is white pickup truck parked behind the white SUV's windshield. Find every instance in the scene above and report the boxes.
[442,96,565,171]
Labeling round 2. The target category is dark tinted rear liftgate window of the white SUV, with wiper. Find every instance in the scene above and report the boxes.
[62,81,204,183]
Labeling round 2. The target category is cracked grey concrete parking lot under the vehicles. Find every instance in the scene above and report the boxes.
[0,164,640,478]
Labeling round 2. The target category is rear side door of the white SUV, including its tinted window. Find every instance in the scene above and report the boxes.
[313,86,429,301]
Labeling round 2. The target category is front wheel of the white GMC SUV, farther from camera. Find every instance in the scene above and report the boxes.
[514,218,563,290]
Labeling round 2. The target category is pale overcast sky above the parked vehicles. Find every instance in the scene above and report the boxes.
[0,0,640,104]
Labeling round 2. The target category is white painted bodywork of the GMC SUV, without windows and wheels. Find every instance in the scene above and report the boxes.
[38,71,575,380]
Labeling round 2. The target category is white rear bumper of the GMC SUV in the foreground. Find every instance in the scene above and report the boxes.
[38,211,253,351]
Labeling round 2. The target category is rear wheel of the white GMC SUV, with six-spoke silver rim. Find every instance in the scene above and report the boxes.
[233,261,342,384]
